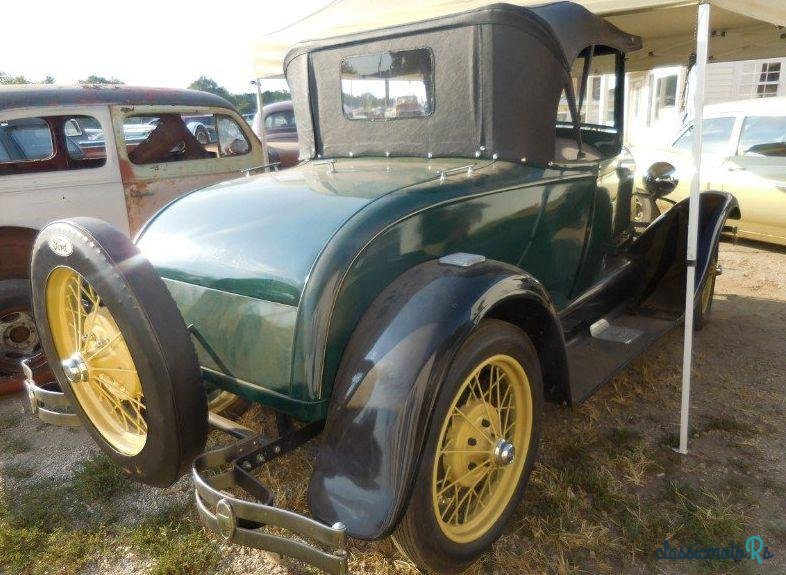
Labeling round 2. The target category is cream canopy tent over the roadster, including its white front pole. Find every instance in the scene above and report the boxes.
[254,0,786,454]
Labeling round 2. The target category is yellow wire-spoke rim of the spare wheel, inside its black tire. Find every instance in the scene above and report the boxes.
[45,266,147,456]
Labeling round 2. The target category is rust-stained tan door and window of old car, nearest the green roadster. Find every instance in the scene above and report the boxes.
[112,105,264,234]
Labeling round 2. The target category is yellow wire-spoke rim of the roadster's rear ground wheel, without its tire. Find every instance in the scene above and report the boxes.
[431,354,533,543]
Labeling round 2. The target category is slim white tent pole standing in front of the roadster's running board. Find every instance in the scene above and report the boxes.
[677,0,710,455]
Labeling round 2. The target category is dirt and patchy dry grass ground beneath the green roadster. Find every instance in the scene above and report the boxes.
[0,243,786,575]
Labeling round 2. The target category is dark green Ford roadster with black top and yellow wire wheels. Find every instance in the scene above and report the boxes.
[23,2,736,573]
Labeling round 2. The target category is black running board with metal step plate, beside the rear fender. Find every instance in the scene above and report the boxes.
[566,314,677,404]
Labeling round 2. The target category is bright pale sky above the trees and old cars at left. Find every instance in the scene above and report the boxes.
[0,0,328,93]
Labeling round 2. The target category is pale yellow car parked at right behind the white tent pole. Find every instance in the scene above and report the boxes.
[633,98,786,245]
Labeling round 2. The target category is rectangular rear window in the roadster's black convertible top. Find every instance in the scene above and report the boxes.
[341,48,434,121]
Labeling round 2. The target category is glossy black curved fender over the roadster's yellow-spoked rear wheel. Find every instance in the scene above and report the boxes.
[309,260,559,539]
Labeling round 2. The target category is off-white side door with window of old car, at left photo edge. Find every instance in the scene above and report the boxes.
[0,106,129,233]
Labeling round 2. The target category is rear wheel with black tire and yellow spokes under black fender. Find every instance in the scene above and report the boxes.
[393,320,543,573]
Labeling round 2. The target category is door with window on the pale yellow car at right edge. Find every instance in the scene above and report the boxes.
[719,115,786,245]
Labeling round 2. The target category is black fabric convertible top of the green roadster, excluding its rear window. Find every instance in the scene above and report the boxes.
[284,2,641,164]
